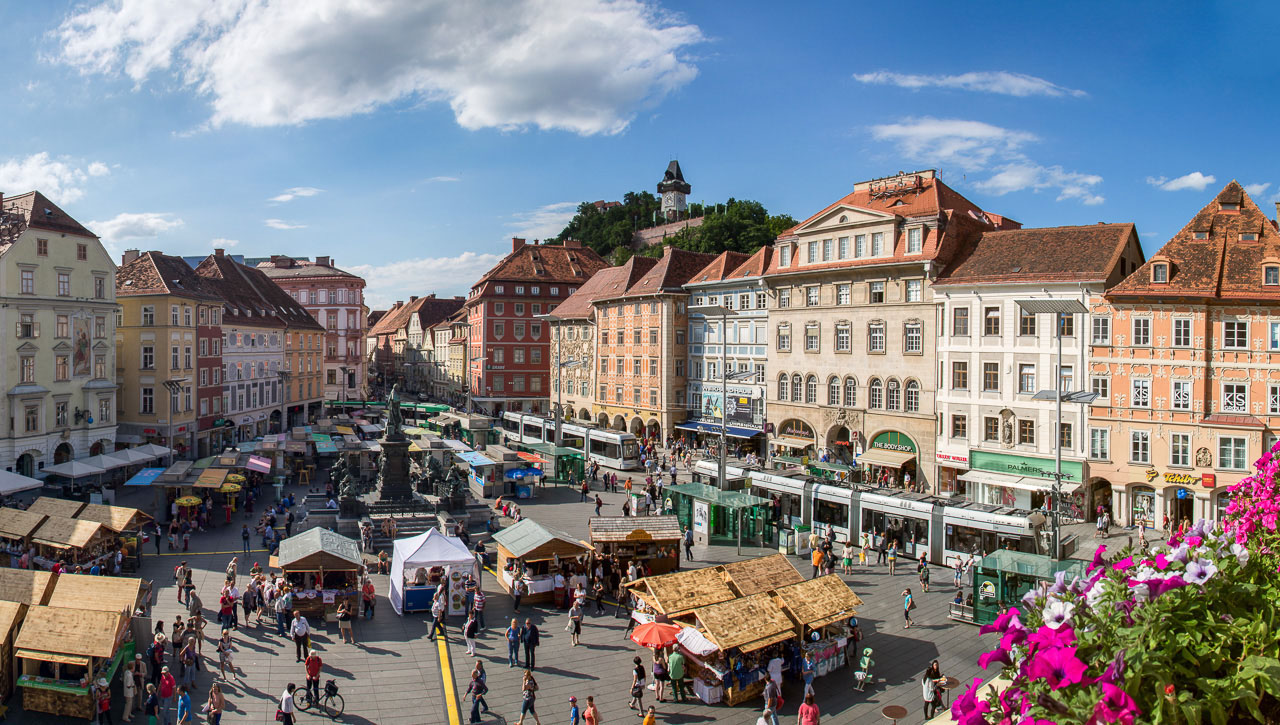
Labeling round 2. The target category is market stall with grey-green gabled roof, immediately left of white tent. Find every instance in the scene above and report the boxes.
[270,528,364,617]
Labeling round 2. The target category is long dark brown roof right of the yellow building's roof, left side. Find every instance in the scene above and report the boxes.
[196,254,324,330]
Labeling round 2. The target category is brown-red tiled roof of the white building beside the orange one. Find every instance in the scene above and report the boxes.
[934,224,1138,284]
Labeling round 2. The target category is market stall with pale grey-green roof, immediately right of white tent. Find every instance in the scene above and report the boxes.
[493,519,590,603]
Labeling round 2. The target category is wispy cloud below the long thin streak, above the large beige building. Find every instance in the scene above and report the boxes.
[872,117,1038,170]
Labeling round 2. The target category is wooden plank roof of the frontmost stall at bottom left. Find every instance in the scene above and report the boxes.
[14,607,128,664]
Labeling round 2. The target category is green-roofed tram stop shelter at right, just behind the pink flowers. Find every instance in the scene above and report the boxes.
[948,548,1085,624]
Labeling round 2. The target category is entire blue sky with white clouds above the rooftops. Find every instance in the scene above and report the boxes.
[0,0,1280,306]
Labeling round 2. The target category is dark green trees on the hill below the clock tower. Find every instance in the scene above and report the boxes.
[552,191,796,264]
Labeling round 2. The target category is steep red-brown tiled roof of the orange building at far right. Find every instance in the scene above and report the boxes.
[1107,181,1280,302]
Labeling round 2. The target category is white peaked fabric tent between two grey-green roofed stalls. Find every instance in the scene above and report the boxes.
[390,529,479,615]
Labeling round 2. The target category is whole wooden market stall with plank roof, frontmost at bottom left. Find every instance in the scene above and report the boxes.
[14,606,134,720]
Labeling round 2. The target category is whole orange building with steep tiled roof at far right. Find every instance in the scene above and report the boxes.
[1088,182,1280,528]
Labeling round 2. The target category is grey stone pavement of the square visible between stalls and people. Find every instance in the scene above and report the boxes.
[8,463,992,725]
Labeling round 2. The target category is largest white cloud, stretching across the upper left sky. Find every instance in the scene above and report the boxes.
[52,0,704,134]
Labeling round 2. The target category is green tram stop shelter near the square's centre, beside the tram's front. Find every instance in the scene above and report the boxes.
[666,483,773,550]
